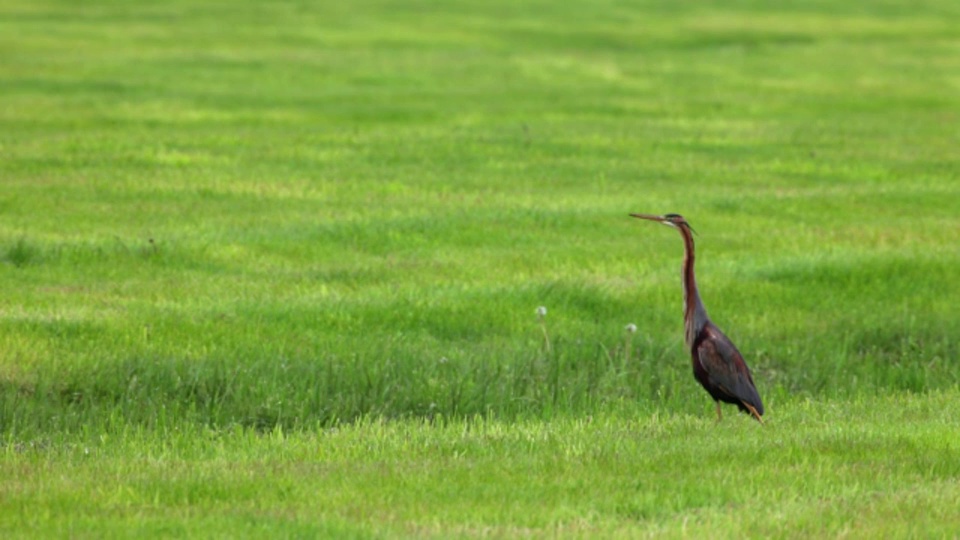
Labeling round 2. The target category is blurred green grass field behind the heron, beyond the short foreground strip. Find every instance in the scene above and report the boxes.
[0,1,960,437]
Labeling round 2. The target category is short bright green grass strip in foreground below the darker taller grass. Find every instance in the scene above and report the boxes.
[0,390,960,538]
